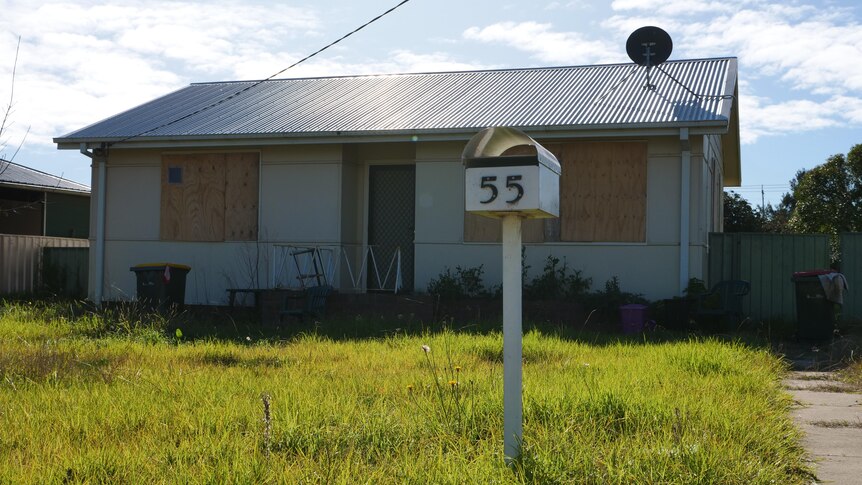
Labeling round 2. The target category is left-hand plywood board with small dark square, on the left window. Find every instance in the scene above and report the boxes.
[160,154,225,241]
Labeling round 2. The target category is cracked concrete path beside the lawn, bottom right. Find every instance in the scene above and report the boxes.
[784,371,862,484]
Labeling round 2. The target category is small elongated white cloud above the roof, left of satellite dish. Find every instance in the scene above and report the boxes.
[464,22,625,64]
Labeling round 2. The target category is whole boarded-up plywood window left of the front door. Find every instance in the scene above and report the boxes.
[160,153,258,241]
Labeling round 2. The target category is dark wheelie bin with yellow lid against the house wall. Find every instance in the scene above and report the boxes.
[129,263,192,311]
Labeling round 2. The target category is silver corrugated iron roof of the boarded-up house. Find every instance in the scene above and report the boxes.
[55,58,736,143]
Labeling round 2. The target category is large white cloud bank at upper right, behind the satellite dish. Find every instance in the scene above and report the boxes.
[603,0,862,143]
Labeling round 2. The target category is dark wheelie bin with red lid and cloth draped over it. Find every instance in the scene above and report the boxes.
[791,270,835,340]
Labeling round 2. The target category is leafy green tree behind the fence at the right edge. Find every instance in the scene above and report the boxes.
[788,144,862,260]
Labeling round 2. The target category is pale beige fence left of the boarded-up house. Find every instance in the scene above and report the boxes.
[0,234,90,295]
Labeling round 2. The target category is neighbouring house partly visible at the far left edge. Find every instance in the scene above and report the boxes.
[0,159,90,239]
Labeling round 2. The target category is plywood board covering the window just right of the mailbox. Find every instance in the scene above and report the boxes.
[560,142,647,242]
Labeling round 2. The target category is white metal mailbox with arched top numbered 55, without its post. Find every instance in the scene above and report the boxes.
[461,127,560,218]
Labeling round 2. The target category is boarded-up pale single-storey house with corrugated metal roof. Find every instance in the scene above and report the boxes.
[54,58,740,303]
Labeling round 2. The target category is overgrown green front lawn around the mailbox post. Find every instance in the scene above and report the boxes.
[0,305,810,484]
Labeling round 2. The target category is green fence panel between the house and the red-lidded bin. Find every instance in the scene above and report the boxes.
[709,233,829,320]
